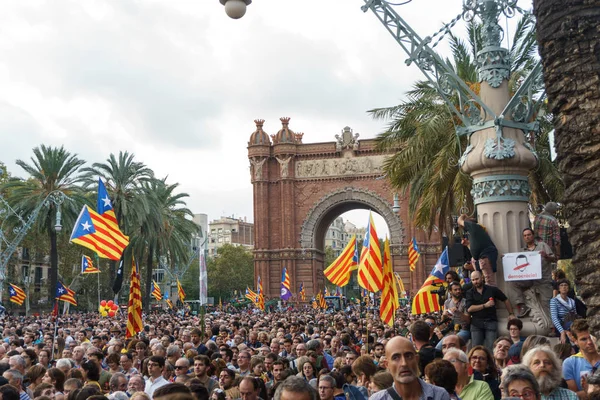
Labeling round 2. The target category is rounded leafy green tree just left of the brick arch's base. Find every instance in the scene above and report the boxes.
[206,244,254,299]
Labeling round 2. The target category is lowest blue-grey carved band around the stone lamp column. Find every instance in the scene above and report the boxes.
[471,175,531,204]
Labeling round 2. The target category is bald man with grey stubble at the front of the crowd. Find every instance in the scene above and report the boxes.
[369,336,450,400]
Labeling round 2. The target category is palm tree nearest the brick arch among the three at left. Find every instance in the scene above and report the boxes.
[133,178,199,311]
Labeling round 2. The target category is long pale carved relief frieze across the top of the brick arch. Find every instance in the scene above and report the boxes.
[296,156,388,178]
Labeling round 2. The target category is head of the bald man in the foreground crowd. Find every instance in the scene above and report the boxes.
[385,336,419,385]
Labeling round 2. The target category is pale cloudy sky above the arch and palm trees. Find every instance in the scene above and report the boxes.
[0,0,530,234]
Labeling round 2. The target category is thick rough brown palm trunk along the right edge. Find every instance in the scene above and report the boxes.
[533,0,600,332]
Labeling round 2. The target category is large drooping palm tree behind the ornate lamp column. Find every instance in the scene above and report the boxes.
[369,18,562,234]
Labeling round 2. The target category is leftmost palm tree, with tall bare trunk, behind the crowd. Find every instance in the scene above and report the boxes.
[2,145,85,297]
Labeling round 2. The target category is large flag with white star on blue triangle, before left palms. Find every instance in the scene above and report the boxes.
[71,206,129,261]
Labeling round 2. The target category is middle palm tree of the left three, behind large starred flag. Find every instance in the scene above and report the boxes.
[82,151,154,288]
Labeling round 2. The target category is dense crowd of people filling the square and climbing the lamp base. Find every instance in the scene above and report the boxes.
[0,205,600,400]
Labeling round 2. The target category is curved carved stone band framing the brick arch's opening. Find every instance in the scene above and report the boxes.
[300,187,405,249]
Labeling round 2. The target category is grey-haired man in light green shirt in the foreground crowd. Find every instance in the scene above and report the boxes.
[444,348,494,400]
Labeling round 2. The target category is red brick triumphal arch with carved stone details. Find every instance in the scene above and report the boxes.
[248,118,441,298]
